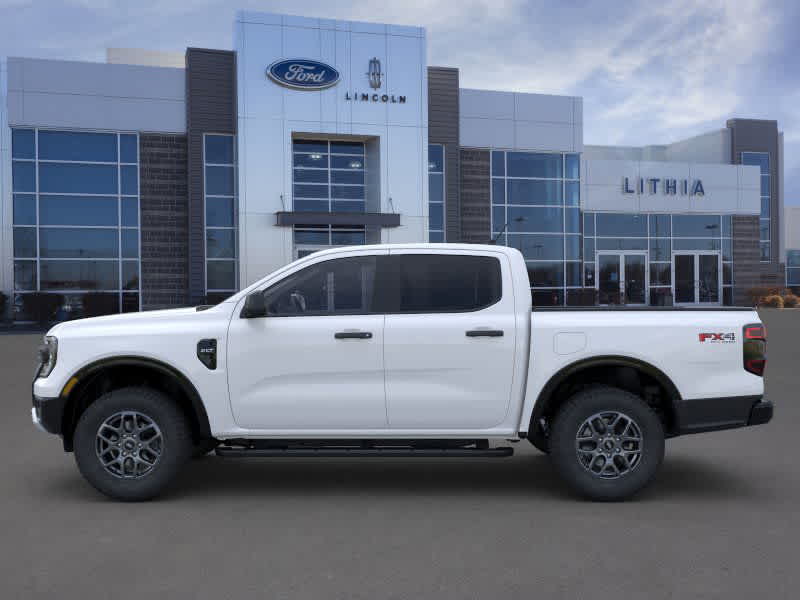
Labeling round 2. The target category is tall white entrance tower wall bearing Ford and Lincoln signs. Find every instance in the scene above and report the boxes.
[234,12,428,287]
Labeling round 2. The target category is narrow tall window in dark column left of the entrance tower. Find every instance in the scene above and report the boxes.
[203,134,238,302]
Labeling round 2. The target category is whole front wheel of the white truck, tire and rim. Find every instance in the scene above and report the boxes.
[74,387,192,501]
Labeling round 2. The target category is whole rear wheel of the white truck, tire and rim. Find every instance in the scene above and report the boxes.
[549,386,664,501]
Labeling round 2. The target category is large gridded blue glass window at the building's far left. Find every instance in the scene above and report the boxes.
[12,129,140,320]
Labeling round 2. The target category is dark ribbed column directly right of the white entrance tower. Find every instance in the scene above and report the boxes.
[428,67,461,242]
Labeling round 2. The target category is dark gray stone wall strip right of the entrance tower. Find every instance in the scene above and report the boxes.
[461,148,492,244]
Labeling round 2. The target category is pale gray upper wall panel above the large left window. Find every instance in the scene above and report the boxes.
[8,58,186,133]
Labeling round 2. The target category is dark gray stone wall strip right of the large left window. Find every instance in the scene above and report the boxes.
[139,133,189,310]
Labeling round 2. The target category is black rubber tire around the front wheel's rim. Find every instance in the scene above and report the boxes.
[74,387,193,502]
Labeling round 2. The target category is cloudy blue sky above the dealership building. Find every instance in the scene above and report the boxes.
[0,0,800,205]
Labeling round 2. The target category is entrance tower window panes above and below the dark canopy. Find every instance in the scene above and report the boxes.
[292,140,366,258]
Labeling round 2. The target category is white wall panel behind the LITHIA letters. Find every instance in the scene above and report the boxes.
[581,158,761,215]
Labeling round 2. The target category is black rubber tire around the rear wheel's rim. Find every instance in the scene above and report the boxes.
[549,386,664,501]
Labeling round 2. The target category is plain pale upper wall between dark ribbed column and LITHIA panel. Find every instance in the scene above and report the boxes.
[459,89,583,152]
